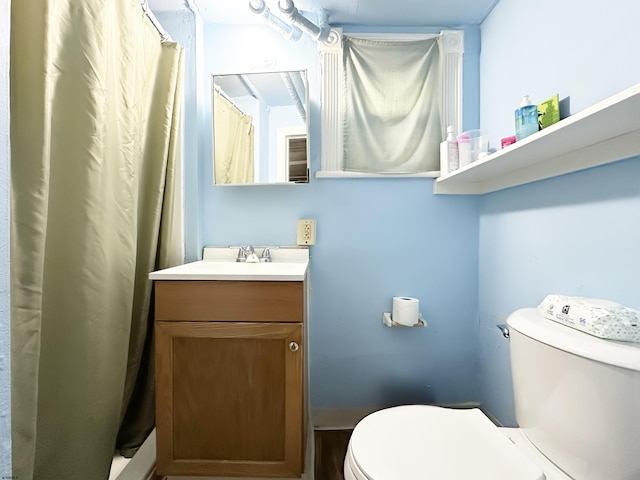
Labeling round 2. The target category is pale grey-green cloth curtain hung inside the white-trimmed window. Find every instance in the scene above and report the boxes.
[343,36,443,173]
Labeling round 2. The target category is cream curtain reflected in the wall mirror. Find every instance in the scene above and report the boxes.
[213,91,254,185]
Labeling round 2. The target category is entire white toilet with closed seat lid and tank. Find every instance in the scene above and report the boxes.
[344,308,640,480]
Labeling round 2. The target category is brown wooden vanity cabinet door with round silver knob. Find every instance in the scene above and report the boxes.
[155,321,305,477]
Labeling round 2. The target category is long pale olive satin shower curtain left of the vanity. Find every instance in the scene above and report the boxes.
[10,0,183,480]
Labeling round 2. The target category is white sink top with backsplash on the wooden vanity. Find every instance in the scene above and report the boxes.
[149,247,309,281]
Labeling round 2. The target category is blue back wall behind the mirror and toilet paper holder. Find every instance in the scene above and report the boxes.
[199,25,479,408]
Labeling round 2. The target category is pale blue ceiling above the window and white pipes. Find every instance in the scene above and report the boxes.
[149,0,499,27]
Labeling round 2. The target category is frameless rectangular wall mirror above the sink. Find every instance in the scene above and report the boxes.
[211,70,309,185]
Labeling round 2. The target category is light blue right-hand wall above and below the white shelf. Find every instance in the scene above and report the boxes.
[478,0,640,425]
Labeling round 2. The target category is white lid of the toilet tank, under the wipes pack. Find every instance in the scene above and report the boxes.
[507,308,640,372]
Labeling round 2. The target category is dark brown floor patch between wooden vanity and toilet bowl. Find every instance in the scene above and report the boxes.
[315,430,352,480]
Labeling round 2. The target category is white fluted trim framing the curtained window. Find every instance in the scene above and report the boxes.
[316,28,464,178]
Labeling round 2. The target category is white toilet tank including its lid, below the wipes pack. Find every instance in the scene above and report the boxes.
[507,308,640,480]
